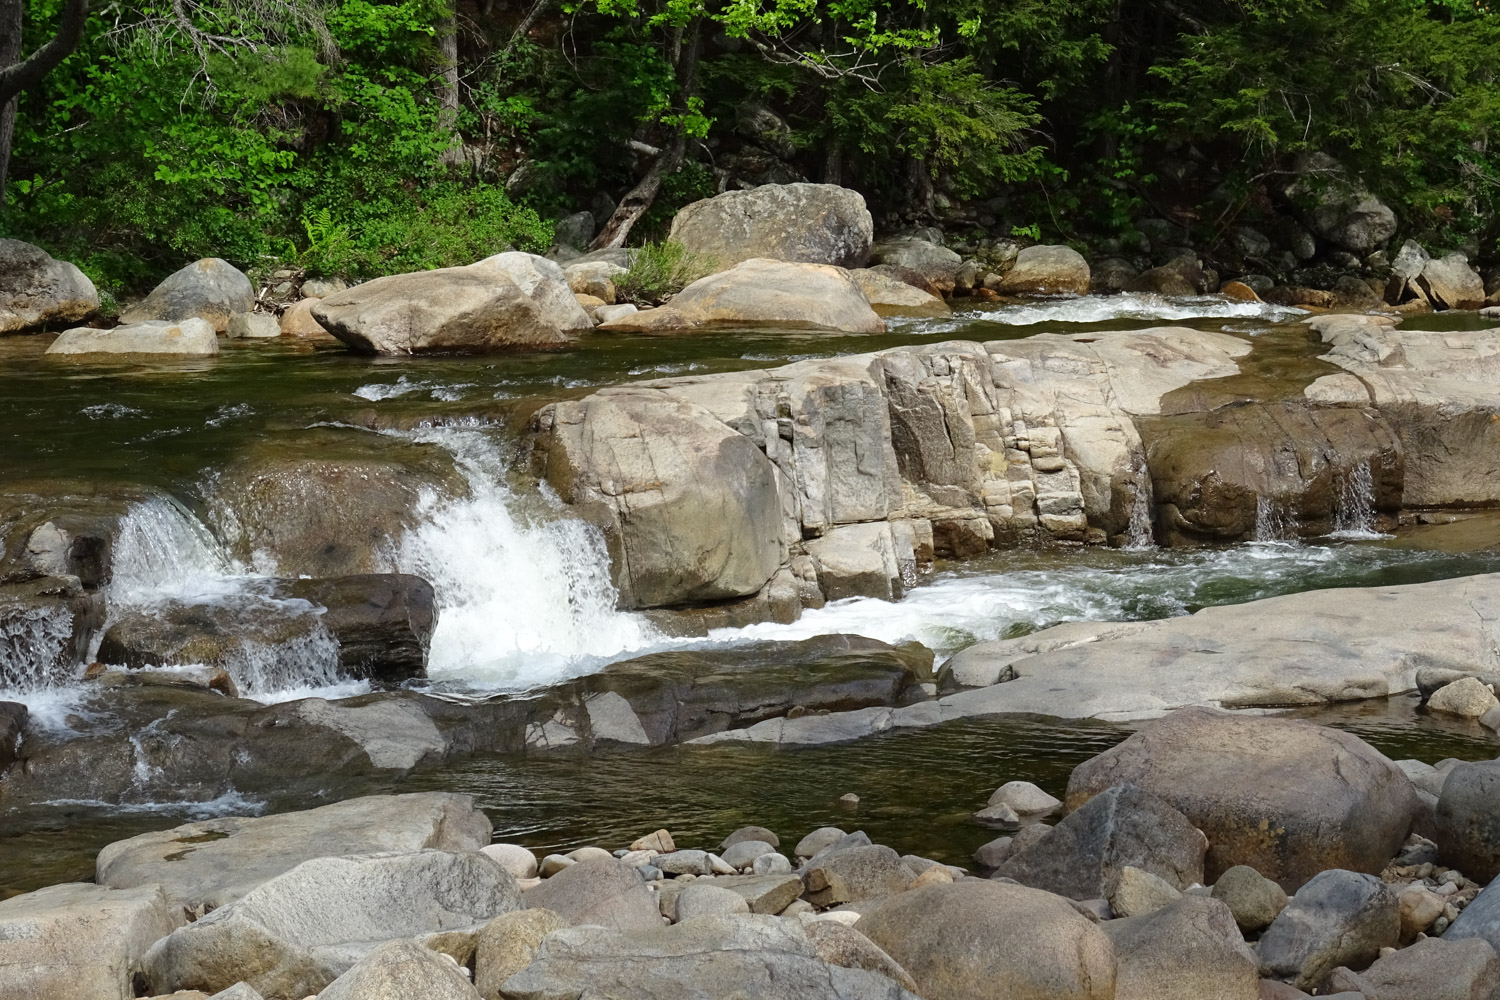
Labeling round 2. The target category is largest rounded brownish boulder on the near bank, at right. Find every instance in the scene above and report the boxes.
[1067,708,1418,892]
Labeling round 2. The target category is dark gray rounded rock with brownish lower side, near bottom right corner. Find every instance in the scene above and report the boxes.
[1257,868,1401,990]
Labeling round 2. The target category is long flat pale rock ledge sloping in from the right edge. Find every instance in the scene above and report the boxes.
[692,574,1500,744]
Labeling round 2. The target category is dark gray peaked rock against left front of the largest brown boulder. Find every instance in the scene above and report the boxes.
[996,784,1209,900]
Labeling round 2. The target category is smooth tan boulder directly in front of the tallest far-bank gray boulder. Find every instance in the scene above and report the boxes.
[600,258,885,333]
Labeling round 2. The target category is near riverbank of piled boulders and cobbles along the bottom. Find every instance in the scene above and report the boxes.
[0,709,1500,1000]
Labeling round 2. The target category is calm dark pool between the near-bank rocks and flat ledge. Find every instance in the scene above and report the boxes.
[0,697,1500,895]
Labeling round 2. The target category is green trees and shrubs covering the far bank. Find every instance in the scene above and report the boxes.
[0,0,1500,289]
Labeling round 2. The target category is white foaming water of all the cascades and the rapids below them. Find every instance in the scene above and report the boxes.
[0,413,1464,712]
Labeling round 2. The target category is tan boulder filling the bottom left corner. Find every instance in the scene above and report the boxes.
[0,883,183,1000]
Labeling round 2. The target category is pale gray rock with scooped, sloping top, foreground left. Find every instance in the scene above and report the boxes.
[144,850,521,1000]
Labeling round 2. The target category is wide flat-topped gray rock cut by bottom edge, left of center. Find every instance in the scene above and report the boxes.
[503,915,915,1000]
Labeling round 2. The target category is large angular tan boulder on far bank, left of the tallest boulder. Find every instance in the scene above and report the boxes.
[311,265,573,354]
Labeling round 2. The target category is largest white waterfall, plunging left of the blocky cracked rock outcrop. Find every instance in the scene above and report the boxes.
[390,427,662,688]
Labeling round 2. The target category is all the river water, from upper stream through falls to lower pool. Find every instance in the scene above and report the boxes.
[0,297,1500,889]
